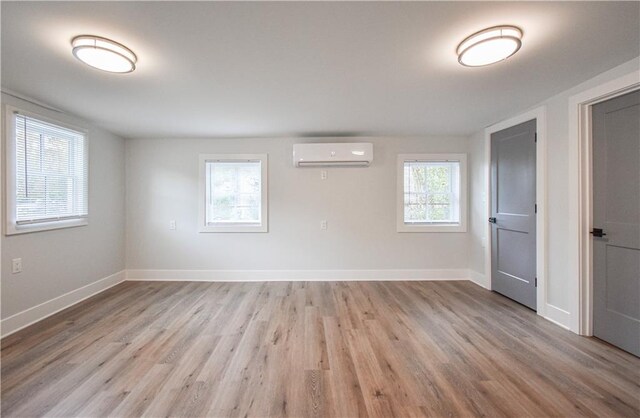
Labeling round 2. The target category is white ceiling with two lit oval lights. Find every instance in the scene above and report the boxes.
[1,1,640,137]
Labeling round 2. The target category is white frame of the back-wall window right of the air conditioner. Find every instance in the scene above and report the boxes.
[396,153,469,232]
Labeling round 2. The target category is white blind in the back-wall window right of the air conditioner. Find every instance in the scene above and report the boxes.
[404,161,460,224]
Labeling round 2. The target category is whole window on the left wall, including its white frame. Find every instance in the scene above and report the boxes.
[6,106,88,235]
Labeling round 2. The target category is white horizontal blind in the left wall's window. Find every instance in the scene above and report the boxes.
[14,113,88,225]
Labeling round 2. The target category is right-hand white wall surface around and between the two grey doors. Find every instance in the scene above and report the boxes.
[469,58,640,327]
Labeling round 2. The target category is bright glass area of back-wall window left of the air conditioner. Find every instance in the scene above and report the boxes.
[206,161,262,224]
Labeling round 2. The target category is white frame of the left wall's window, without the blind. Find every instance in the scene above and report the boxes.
[4,105,90,235]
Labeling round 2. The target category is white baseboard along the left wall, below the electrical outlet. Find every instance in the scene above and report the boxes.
[0,270,126,338]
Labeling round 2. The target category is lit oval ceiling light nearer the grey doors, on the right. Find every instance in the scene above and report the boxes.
[456,26,522,67]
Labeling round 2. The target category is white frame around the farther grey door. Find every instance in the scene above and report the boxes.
[484,106,556,316]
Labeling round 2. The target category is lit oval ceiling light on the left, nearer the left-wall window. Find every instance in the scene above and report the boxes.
[71,35,138,73]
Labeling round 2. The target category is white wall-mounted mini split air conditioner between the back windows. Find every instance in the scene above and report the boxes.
[293,142,373,167]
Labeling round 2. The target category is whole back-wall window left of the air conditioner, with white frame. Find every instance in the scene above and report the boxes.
[199,154,267,232]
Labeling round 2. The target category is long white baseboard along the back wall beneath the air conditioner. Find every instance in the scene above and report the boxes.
[127,269,469,282]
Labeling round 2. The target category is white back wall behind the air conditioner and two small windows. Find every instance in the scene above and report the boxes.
[127,137,468,277]
